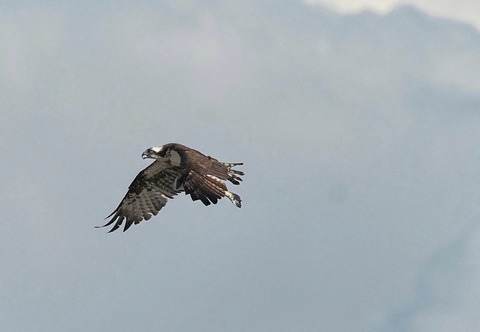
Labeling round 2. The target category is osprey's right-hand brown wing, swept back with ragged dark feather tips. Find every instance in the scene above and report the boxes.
[183,161,244,207]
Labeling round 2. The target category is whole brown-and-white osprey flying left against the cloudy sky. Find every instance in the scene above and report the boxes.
[99,143,244,233]
